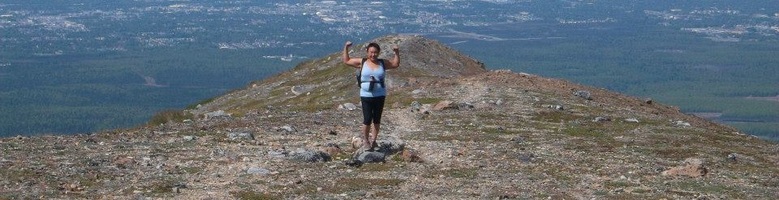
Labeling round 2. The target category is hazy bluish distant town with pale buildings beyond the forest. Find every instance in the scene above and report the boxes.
[0,0,779,59]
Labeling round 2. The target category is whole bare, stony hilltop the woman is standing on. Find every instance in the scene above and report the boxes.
[0,35,779,199]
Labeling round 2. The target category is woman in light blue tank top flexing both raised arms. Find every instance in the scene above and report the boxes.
[343,41,400,149]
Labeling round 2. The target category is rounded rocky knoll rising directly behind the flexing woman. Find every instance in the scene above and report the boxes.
[195,35,486,114]
